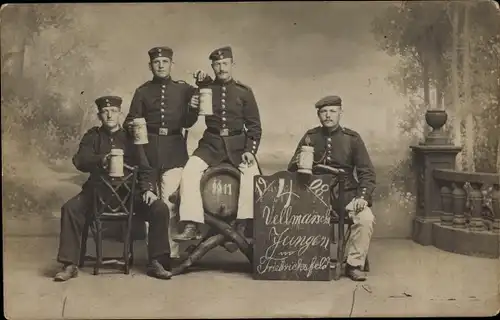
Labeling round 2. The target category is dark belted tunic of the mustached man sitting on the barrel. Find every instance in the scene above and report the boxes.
[193,79,262,166]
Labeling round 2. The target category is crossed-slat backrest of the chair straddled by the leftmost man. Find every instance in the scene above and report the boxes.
[93,165,138,217]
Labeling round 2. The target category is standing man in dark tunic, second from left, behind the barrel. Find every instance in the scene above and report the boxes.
[125,46,211,258]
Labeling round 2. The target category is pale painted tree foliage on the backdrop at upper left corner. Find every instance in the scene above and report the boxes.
[2,5,109,158]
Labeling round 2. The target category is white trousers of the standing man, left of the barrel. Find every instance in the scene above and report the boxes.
[146,168,182,258]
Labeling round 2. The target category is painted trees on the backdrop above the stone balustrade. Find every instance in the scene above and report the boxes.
[373,1,500,171]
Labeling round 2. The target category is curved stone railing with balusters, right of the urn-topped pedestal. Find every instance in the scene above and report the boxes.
[432,169,500,258]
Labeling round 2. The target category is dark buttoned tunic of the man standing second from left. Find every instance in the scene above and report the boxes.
[125,77,205,178]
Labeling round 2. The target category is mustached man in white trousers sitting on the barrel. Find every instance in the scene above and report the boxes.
[173,47,262,241]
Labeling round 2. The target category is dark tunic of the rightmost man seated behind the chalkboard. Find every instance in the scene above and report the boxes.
[288,126,375,205]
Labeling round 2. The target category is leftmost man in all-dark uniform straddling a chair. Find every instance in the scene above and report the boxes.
[54,96,172,281]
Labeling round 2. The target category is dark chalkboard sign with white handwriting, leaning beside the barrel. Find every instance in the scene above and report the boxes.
[253,171,333,281]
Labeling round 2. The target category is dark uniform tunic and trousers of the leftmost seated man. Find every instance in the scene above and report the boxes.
[57,127,170,264]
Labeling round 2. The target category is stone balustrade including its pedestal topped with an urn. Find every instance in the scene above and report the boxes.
[411,110,500,258]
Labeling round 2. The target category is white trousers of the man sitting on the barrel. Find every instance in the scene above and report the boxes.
[179,156,259,223]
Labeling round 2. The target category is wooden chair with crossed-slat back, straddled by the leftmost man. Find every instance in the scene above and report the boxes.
[79,164,138,275]
